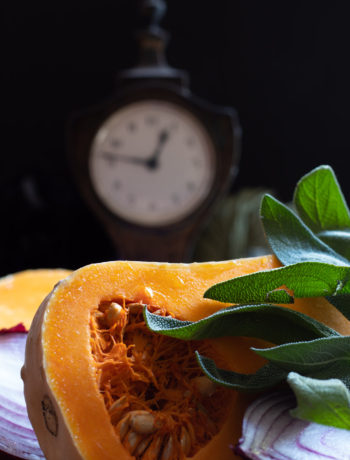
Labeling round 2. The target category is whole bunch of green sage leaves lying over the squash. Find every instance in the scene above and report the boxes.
[144,166,350,429]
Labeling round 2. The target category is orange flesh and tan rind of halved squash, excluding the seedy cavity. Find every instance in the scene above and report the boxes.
[23,256,350,460]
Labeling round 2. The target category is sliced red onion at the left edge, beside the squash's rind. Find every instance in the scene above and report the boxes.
[0,332,45,460]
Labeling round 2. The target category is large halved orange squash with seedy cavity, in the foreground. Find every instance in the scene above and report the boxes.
[22,256,350,460]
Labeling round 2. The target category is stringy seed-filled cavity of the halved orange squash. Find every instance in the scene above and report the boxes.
[90,298,232,460]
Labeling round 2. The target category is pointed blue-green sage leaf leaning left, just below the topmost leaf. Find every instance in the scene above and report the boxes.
[260,195,349,266]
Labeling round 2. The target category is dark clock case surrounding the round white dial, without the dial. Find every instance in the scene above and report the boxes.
[68,80,240,260]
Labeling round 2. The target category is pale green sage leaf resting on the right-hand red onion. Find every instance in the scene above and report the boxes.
[287,372,350,430]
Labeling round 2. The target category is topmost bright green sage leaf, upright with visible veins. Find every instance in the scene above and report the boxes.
[294,166,350,233]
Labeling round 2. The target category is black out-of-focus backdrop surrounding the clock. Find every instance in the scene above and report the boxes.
[0,0,350,275]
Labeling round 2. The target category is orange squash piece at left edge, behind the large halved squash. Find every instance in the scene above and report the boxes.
[0,268,71,332]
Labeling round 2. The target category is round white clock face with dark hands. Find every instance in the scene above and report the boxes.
[89,100,215,226]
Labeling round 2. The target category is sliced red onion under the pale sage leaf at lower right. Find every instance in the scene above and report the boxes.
[234,393,350,460]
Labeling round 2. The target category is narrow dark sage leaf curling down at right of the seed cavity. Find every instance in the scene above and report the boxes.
[196,352,288,391]
